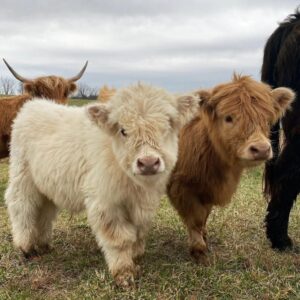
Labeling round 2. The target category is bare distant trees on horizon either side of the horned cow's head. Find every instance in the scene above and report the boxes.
[0,77,98,100]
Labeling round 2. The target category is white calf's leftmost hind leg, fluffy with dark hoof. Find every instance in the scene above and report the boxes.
[5,172,44,257]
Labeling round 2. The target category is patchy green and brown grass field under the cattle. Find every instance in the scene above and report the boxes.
[0,100,300,300]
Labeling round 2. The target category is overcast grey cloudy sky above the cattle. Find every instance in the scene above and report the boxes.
[0,0,299,91]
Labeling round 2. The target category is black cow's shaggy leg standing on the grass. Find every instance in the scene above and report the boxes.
[265,144,300,250]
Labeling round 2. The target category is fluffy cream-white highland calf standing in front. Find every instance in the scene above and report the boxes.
[5,84,199,286]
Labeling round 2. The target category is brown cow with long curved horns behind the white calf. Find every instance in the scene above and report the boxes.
[0,59,87,159]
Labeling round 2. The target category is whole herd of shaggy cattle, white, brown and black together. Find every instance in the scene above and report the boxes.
[0,12,300,287]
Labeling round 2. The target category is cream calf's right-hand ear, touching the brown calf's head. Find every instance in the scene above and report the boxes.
[177,95,199,127]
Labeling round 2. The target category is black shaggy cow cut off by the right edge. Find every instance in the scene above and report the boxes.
[262,9,300,250]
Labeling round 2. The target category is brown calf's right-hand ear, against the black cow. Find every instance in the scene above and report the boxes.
[271,87,296,118]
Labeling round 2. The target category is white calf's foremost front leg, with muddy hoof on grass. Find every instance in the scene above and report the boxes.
[88,205,138,287]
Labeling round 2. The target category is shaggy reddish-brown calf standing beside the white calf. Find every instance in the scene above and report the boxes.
[168,75,295,263]
